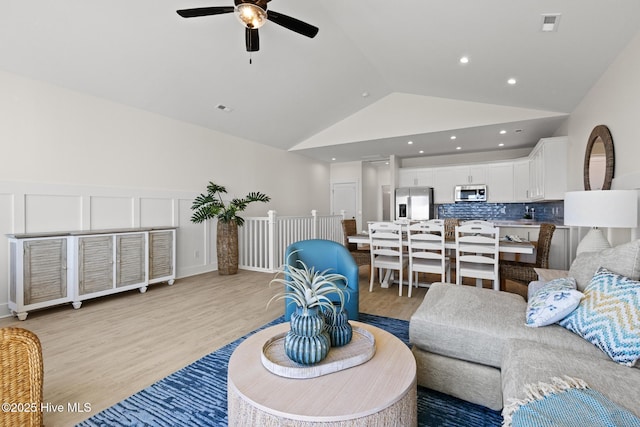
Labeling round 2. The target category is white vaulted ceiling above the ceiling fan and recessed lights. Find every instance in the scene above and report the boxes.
[0,0,640,161]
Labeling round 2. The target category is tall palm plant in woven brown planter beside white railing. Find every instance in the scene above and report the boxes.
[191,181,271,275]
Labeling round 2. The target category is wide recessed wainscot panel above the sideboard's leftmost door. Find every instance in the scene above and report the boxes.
[24,194,83,233]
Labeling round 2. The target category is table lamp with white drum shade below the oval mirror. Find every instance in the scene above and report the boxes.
[564,190,638,254]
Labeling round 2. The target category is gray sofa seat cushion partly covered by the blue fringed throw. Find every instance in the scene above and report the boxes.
[502,340,640,416]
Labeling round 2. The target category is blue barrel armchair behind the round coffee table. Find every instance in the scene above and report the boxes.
[284,239,359,320]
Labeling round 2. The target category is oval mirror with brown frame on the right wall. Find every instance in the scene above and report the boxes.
[584,125,615,190]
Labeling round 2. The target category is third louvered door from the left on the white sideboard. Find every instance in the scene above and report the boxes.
[116,233,146,287]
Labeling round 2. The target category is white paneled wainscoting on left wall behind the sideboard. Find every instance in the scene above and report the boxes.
[0,181,217,317]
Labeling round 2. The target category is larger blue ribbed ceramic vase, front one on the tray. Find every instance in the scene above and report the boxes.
[284,307,331,365]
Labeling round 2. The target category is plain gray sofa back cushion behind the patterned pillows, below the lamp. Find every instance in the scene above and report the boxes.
[569,240,640,291]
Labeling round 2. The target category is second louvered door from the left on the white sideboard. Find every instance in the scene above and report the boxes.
[78,236,113,295]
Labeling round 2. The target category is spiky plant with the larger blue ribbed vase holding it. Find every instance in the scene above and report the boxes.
[267,252,351,365]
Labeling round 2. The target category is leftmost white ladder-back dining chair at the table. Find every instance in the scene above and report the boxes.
[369,222,408,296]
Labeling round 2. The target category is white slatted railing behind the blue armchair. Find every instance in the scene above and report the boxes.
[238,210,344,272]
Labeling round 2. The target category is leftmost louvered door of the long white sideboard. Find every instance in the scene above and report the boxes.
[23,239,67,305]
